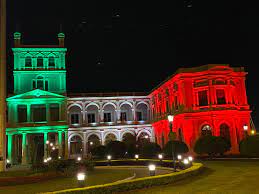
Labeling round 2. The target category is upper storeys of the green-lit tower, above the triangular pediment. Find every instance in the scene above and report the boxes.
[12,32,67,94]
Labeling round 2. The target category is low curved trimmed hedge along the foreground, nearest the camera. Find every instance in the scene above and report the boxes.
[45,163,203,194]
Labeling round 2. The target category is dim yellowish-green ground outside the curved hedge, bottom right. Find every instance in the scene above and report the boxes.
[123,161,259,194]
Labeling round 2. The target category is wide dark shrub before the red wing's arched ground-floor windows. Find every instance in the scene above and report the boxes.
[194,135,230,156]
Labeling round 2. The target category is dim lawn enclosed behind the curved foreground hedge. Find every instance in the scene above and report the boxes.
[0,166,174,194]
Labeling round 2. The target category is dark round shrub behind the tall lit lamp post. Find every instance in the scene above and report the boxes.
[163,141,189,157]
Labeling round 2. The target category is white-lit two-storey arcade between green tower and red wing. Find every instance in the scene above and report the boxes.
[67,93,155,157]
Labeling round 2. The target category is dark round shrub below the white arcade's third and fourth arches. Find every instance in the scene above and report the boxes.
[105,141,126,158]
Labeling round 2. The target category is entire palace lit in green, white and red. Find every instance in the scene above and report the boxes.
[6,32,253,164]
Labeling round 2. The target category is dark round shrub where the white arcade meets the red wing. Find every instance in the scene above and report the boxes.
[139,142,161,157]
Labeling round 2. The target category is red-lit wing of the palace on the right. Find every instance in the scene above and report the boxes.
[149,64,250,153]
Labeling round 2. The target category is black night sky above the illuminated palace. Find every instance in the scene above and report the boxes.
[7,0,259,126]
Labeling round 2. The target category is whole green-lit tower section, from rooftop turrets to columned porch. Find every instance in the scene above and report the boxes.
[6,32,68,164]
